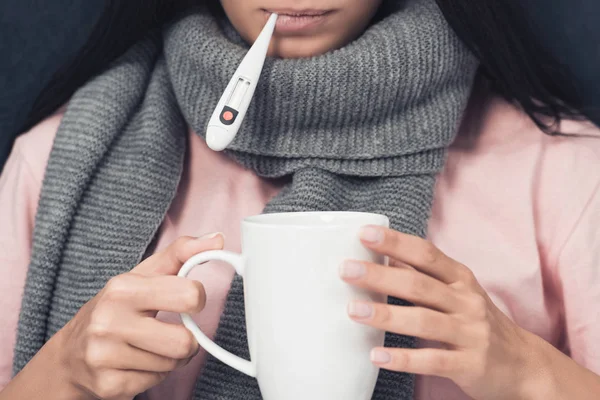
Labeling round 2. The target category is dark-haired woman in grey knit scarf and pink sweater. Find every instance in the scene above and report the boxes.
[0,0,600,400]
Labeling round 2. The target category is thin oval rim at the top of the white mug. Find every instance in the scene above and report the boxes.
[242,211,390,229]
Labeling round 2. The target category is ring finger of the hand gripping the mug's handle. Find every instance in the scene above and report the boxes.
[85,340,187,372]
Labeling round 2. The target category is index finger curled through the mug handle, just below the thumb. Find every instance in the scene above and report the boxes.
[103,273,206,314]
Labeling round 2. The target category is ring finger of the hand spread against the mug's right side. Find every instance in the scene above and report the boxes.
[348,301,471,347]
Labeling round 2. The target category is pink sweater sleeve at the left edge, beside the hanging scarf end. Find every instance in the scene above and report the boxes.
[0,113,62,390]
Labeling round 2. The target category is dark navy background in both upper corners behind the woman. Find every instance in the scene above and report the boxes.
[0,0,600,170]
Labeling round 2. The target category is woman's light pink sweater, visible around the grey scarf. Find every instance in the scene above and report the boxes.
[0,94,600,400]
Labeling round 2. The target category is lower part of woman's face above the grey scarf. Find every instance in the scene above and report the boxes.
[221,0,382,58]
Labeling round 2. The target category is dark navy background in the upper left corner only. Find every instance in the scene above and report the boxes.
[0,0,104,170]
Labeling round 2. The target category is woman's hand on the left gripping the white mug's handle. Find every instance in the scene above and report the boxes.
[55,234,223,400]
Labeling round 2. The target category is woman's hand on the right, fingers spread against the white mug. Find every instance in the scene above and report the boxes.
[340,227,541,400]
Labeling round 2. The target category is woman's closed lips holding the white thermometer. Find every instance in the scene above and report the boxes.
[262,9,333,34]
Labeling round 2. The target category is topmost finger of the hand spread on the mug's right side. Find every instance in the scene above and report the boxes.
[361,226,468,283]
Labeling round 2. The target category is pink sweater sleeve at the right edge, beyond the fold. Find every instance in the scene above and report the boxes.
[557,180,600,374]
